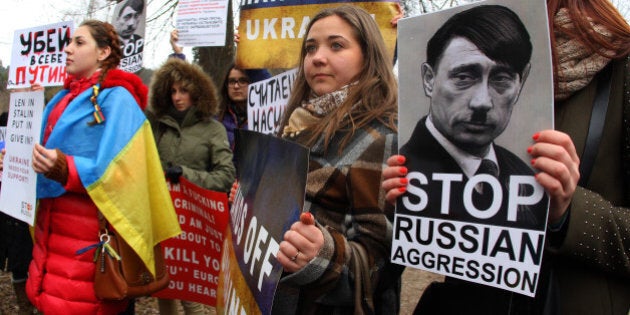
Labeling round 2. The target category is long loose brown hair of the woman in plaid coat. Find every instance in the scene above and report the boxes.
[279,5,398,152]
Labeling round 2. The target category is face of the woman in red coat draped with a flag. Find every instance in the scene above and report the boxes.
[64,26,111,78]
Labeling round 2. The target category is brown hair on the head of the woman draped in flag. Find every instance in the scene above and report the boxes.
[79,20,122,81]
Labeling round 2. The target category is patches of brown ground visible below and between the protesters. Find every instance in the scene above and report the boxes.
[0,268,443,315]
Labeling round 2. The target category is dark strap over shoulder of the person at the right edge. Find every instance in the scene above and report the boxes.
[578,62,613,187]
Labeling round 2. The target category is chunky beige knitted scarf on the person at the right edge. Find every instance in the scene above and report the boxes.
[553,8,610,101]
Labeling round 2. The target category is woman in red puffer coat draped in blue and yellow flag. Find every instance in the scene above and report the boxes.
[27,20,180,315]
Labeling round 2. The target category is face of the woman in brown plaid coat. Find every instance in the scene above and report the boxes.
[304,15,363,95]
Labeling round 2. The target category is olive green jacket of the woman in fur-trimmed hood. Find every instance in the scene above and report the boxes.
[147,106,236,192]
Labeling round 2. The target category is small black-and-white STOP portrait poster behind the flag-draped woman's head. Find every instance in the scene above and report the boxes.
[111,0,147,72]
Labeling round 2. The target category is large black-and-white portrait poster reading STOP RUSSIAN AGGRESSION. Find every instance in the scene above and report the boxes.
[391,0,553,296]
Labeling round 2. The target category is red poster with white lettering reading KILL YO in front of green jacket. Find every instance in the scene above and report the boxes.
[154,177,230,306]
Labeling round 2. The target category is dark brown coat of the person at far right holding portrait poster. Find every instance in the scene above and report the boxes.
[546,58,630,315]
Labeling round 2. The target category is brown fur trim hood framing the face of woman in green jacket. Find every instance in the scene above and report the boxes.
[149,58,218,118]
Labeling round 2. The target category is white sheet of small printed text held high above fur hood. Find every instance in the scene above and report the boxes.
[176,0,231,47]
